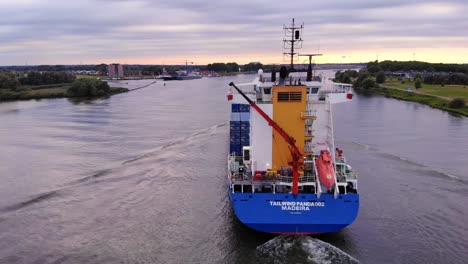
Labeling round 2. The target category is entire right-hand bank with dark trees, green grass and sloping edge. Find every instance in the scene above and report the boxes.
[335,61,468,117]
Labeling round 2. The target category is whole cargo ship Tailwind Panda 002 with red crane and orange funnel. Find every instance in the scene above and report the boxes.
[227,20,359,234]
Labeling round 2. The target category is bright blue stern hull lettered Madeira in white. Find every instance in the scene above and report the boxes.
[229,192,359,234]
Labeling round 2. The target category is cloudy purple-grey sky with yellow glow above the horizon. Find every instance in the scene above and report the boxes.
[0,0,468,65]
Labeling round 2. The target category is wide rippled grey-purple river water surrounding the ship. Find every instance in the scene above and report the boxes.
[0,72,468,263]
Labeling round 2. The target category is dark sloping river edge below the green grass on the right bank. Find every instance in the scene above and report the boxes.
[369,86,468,117]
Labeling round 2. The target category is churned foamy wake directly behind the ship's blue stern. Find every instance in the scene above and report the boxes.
[256,235,359,264]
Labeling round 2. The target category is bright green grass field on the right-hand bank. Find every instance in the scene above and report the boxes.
[382,80,468,102]
